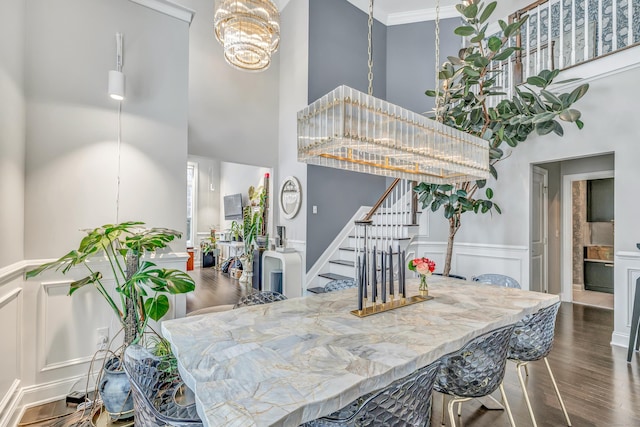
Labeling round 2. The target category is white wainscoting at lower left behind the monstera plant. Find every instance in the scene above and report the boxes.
[0,253,188,427]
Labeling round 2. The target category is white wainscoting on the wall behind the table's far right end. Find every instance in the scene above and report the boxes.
[417,242,529,289]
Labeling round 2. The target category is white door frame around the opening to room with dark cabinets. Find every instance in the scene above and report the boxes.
[560,170,615,302]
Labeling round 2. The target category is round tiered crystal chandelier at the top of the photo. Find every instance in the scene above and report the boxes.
[213,0,280,71]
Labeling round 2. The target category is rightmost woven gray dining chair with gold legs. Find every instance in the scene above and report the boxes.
[507,302,571,427]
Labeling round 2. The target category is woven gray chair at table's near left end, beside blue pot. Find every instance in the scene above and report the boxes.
[124,344,202,427]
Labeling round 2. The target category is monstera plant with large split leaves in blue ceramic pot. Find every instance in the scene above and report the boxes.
[27,222,195,419]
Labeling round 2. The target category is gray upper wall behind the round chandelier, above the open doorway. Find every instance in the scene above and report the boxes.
[177,0,280,167]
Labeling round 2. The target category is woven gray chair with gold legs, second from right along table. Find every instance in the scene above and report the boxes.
[433,325,515,427]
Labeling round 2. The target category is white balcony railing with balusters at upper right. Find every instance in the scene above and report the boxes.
[493,0,640,102]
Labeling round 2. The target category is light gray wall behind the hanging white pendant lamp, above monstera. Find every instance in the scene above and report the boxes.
[25,0,189,259]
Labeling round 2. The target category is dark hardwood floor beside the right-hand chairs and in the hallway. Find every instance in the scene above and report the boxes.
[21,276,640,427]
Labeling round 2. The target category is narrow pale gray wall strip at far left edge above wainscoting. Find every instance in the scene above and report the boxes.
[0,0,25,270]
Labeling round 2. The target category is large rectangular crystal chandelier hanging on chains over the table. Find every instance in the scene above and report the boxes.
[298,86,489,184]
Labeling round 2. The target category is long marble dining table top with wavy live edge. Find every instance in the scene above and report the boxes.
[162,276,558,427]
